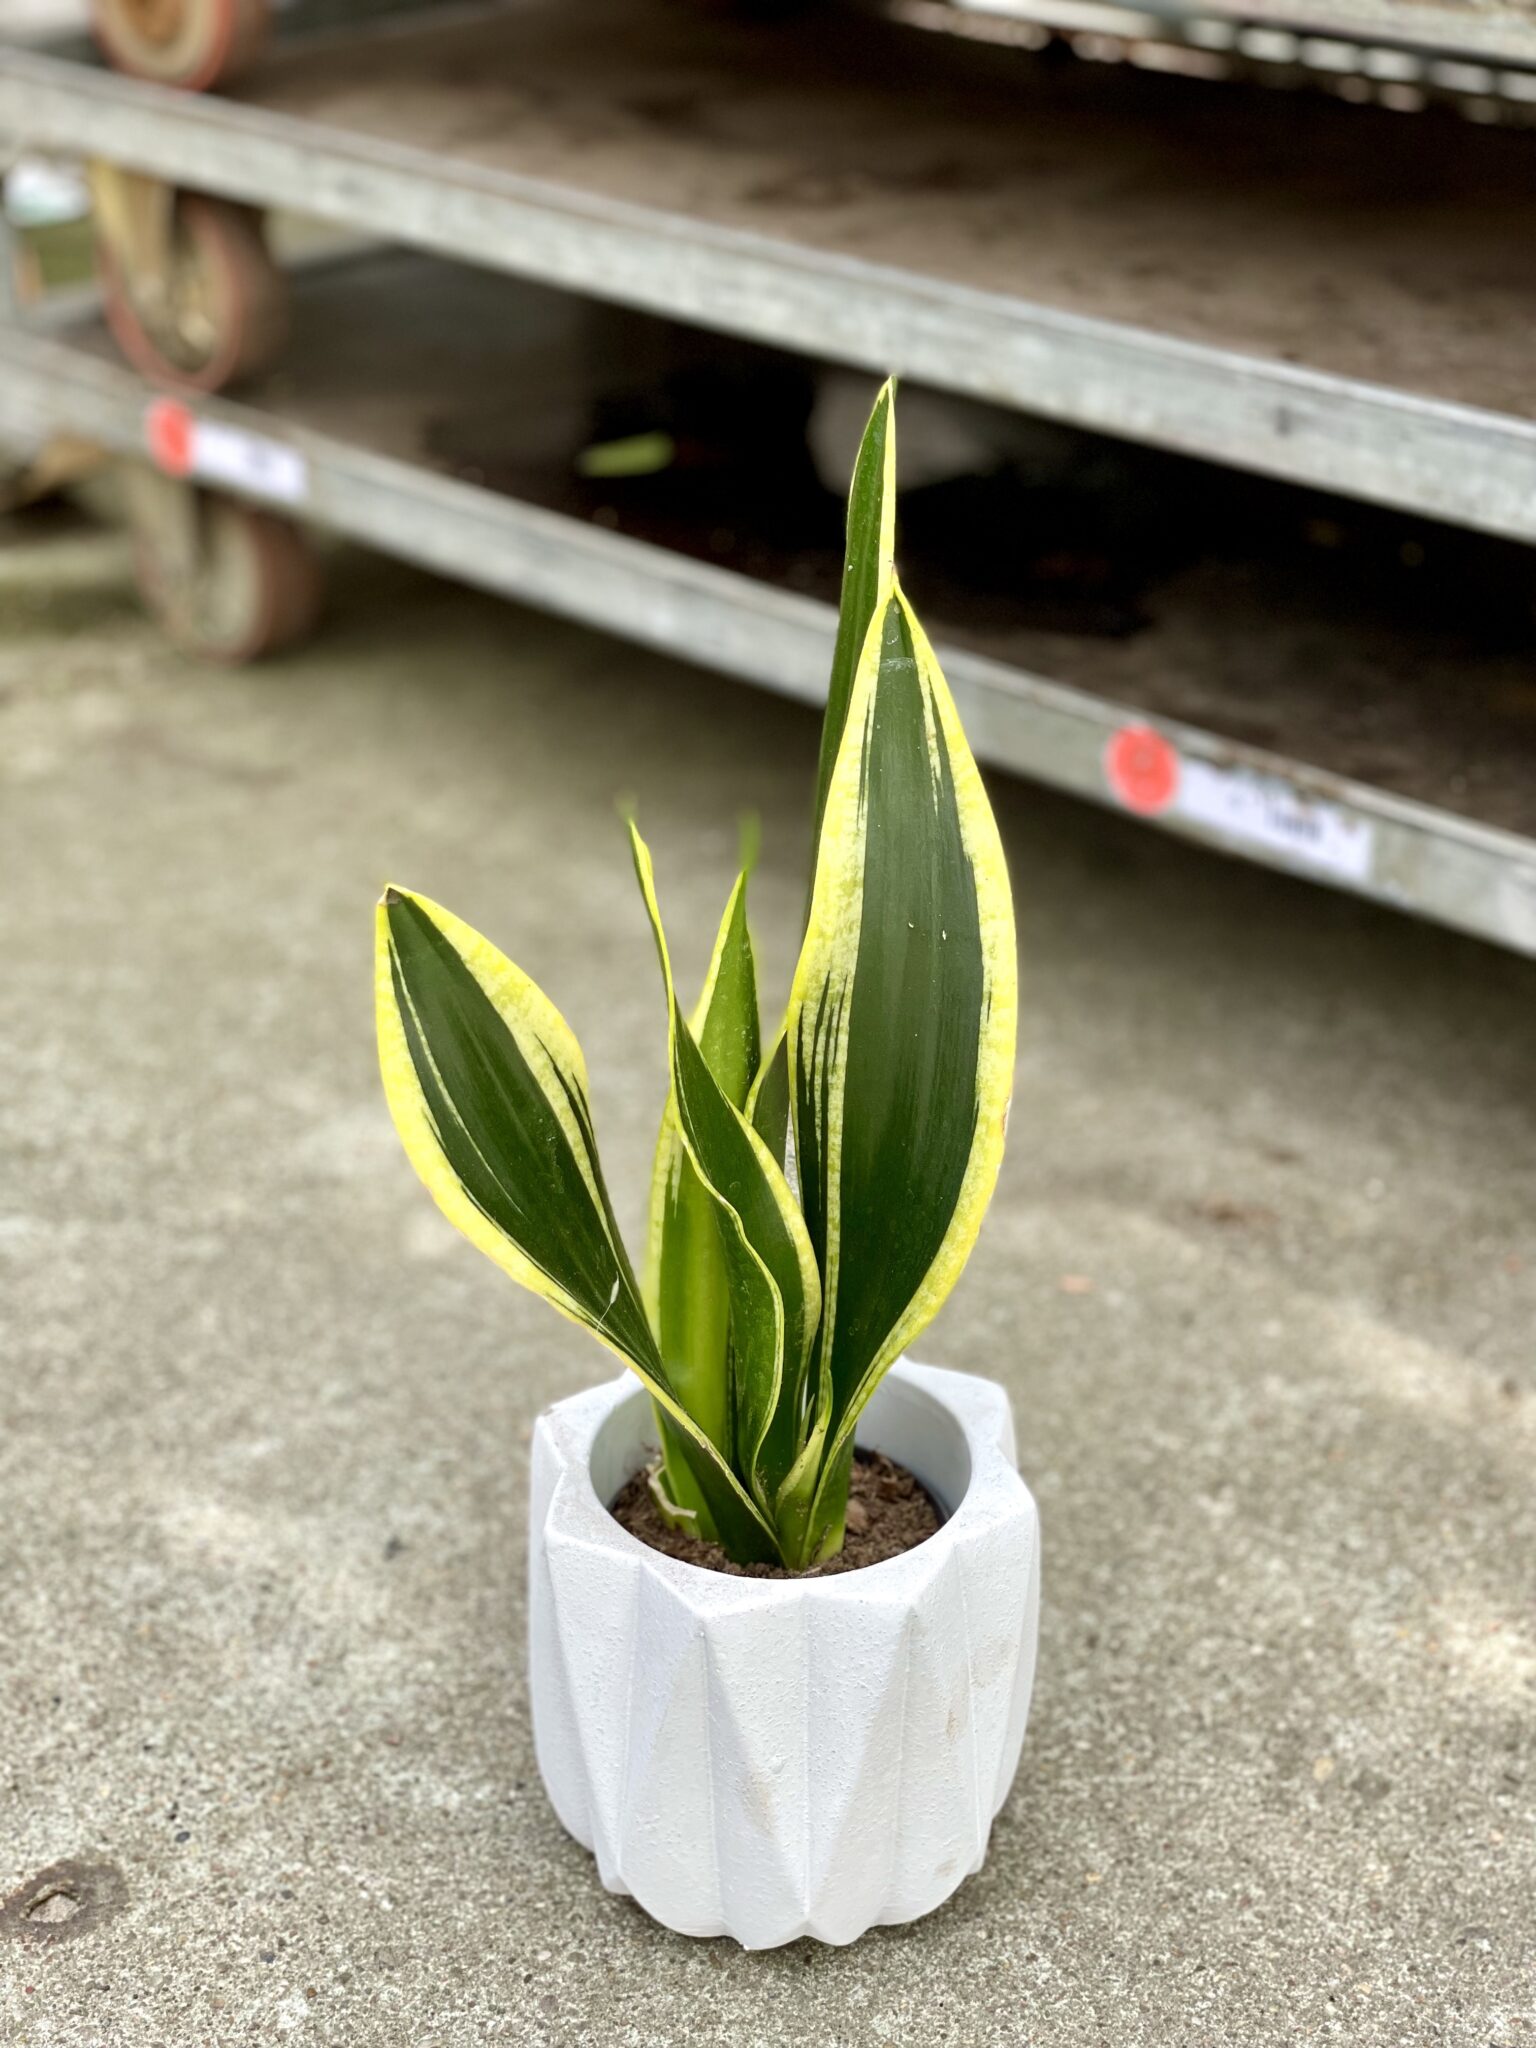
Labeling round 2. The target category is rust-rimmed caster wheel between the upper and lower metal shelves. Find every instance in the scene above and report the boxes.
[98,193,289,391]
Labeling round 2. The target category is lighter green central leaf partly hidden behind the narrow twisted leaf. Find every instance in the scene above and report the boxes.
[645,868,762,1536]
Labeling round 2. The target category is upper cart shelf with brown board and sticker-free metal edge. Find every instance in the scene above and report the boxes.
[0,0,1536,541]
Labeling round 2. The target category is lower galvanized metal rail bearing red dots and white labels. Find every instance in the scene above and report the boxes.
[0,328,1536,954]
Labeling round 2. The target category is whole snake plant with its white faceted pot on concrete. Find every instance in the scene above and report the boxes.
[377,385,1038,1948]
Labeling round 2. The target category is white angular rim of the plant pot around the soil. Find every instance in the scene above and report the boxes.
[541,1358,1032,1604]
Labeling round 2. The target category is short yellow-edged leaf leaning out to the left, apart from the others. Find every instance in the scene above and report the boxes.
[375,889,776,1559]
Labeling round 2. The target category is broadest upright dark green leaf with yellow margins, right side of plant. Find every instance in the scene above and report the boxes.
[786,573,1018,1542]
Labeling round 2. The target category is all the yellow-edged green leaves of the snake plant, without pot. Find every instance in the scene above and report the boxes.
[379,383,1018,1567]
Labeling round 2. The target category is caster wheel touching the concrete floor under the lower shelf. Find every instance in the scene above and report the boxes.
[131,479,324,668]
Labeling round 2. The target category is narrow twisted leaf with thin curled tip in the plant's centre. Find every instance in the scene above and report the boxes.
[629,823,821,1511]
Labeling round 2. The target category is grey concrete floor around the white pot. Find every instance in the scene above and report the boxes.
[0,524,1536,2048]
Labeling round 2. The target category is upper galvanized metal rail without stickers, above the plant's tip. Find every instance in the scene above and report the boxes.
[0,53,1536,541]
